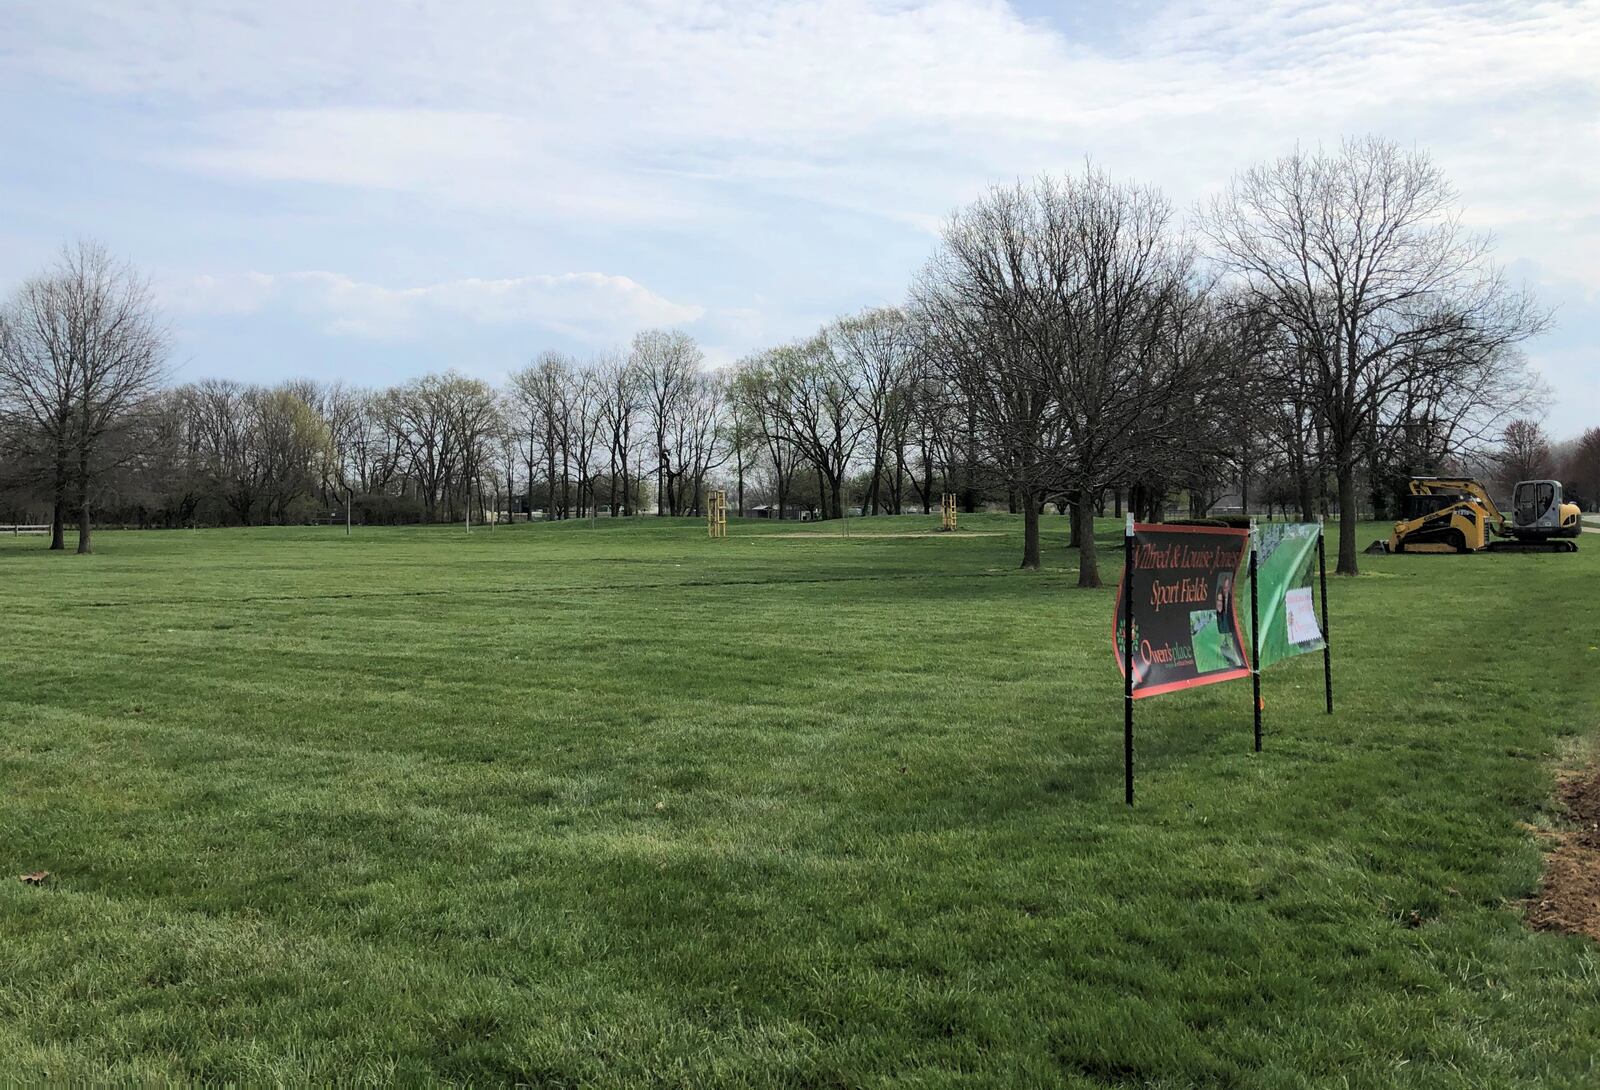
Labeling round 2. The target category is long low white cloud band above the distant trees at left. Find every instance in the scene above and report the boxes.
[163,272,706,346]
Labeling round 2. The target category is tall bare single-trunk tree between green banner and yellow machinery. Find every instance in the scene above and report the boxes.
[1205,138,1547,575]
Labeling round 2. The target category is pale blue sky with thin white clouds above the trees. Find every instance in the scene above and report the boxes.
[0,0,1600,435]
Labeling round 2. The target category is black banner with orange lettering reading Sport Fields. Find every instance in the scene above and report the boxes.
[1114,523,1250,698]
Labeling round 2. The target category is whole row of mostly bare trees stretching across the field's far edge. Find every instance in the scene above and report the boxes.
[0,138,1600,586]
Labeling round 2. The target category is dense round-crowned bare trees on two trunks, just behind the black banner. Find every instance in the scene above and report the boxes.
[917,168,1196,587]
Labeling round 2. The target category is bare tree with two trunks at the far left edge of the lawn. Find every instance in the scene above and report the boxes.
[0,242,168,552]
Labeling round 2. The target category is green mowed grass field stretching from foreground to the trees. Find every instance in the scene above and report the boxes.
[0,515,1600,1087]
